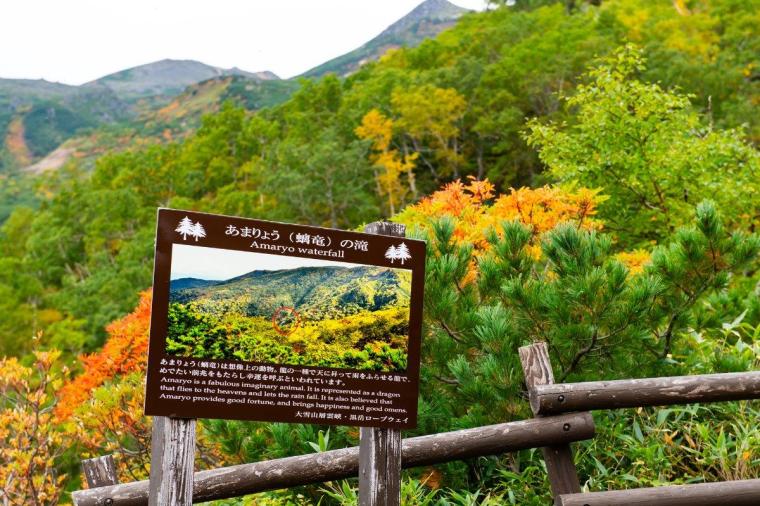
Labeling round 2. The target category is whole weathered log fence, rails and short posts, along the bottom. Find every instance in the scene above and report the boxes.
[73,343,760,506]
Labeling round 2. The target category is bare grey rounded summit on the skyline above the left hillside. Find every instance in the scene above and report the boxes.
[83,59,279,101]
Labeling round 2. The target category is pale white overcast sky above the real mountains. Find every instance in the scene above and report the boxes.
[0,0,485,85]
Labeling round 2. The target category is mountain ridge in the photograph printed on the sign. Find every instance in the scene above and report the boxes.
[171,266,411,319]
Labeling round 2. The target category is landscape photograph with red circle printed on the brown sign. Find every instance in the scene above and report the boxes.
[166,243,412,372]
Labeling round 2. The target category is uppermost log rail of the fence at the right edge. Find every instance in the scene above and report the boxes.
[530,371,760,415]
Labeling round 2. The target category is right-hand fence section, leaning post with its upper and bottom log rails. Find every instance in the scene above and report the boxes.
[520,343,760,506]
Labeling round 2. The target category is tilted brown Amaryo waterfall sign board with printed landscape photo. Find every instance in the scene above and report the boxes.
[145,209,425,428]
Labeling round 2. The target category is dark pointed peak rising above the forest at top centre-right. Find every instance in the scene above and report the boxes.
[302,0,469,77]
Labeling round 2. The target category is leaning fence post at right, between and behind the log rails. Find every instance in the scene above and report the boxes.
[519,343,590,497]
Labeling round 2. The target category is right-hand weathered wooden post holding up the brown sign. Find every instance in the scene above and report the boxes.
[359,221,406,506]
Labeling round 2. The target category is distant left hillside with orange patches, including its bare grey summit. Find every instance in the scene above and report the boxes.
[0,60,280,170]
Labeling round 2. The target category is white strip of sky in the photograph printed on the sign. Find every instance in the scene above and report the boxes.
[170,244,359,280]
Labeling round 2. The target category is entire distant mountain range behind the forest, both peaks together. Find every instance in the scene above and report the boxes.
[0,0,467,172]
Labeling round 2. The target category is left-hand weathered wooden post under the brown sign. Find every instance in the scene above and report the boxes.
[148,416,195,506]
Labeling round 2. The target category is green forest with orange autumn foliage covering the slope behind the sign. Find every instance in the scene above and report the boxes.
[0,0,760,506]
